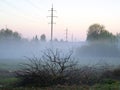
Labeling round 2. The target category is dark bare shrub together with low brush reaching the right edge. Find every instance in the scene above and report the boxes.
[16,49,120,86]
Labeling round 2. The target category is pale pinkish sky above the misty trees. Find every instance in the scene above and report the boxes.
[0,0,120,41]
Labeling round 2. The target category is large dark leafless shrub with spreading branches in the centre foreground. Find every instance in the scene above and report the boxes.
[16,49,77,86]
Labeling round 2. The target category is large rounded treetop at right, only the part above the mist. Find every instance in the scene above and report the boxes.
[87,24,116,41]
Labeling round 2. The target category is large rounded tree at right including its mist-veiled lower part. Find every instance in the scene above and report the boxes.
[77,24,120,58]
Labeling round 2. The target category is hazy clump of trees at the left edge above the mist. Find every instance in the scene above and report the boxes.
[0,29,21,41]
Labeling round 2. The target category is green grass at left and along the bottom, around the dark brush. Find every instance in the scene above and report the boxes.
[0,58,120,90]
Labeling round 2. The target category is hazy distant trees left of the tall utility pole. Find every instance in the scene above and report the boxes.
[0,28,46,42]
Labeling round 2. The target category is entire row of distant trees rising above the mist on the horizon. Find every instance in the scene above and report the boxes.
[0,24,120,42]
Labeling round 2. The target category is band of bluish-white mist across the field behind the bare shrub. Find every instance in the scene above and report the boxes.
[0,41,120,65]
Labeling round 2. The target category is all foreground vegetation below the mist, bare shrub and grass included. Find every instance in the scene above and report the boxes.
[0,50,120,90]
